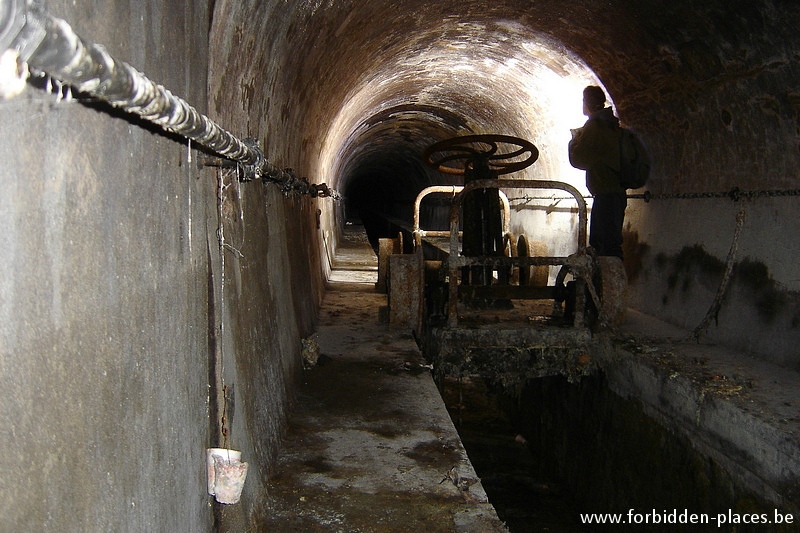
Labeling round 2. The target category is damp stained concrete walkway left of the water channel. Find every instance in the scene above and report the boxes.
[258,283,506,533]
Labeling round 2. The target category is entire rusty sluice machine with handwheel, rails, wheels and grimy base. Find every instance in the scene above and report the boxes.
[379,135,613,387]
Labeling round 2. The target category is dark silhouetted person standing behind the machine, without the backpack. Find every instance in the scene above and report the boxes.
[568,85,628,259]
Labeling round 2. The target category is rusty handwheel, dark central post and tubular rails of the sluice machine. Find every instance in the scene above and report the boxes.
[414,135,600,327]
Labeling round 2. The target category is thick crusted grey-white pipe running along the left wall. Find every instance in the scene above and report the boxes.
[0,0,340,199]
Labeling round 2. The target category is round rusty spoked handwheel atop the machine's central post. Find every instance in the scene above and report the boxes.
[423,135,539,175]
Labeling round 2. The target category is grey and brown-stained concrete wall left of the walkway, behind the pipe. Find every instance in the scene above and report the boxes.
[0,0,321,532]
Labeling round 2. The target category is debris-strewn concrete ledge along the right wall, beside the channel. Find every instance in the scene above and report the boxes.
[593,310,800,517]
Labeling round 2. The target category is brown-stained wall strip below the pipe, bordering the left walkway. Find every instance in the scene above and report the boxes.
[209,171,319,531]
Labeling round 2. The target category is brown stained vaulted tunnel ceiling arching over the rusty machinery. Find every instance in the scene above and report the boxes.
[212,0,800,219]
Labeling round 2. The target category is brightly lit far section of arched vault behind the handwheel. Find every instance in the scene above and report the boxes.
[312,17,608,224]
